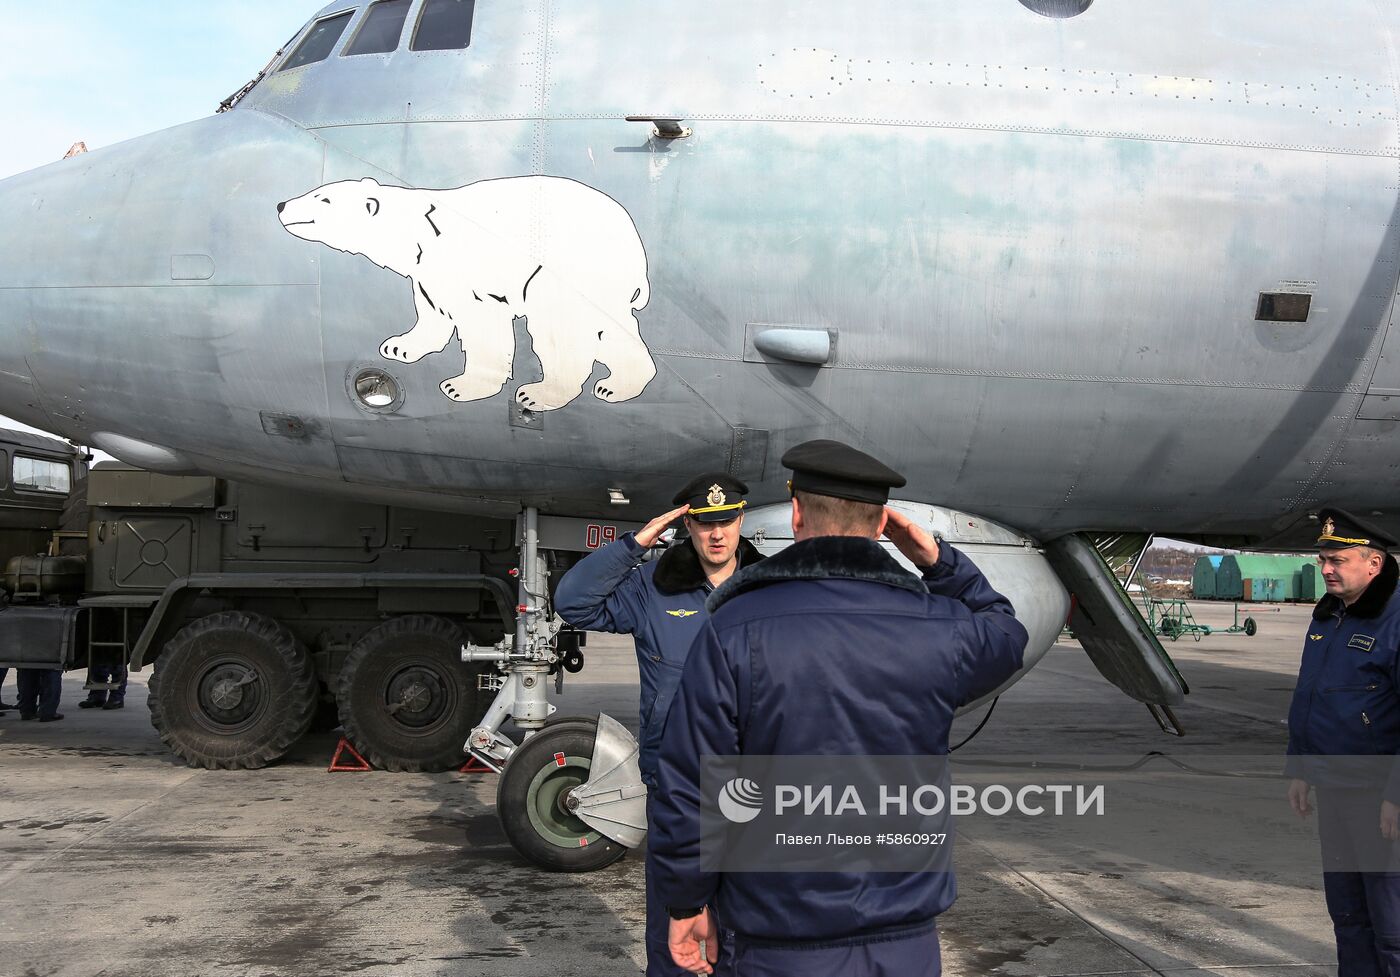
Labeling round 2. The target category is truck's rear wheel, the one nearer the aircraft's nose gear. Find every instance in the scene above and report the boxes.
[336,614,487,771]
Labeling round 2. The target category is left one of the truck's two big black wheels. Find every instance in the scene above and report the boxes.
[150,610,316,770]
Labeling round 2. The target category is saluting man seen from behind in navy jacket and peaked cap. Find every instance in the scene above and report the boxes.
[650,441,1026,977]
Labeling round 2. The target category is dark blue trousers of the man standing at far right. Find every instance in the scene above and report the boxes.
[1317,789,1400,977]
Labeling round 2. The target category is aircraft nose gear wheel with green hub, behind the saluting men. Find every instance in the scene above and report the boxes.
[496,719,627,872]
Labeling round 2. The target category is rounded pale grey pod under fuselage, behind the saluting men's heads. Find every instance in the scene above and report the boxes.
[743,500,1070,712]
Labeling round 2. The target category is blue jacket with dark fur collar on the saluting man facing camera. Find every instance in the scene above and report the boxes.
[554,533,763,785]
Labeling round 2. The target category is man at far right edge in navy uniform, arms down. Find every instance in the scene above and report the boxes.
[1285,508,1400,977]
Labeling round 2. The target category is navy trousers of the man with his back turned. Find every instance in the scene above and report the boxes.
[714,924,944,977]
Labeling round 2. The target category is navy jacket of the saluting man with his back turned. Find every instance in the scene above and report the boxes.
[648,536,1026,943]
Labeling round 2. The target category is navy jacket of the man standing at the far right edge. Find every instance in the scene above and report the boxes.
[1285,556,1400,802]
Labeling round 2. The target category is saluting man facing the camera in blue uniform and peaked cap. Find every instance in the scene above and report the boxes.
[554,472,763,977]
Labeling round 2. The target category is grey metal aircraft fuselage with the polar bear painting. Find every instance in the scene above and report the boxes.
[0,0,1400,542]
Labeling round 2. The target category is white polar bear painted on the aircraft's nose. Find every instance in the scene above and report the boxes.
[277,176,657,410]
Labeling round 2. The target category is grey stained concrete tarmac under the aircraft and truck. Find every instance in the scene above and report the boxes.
[0,602,1336,977]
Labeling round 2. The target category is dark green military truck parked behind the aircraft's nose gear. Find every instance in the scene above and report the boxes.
[0,434,622,770]
